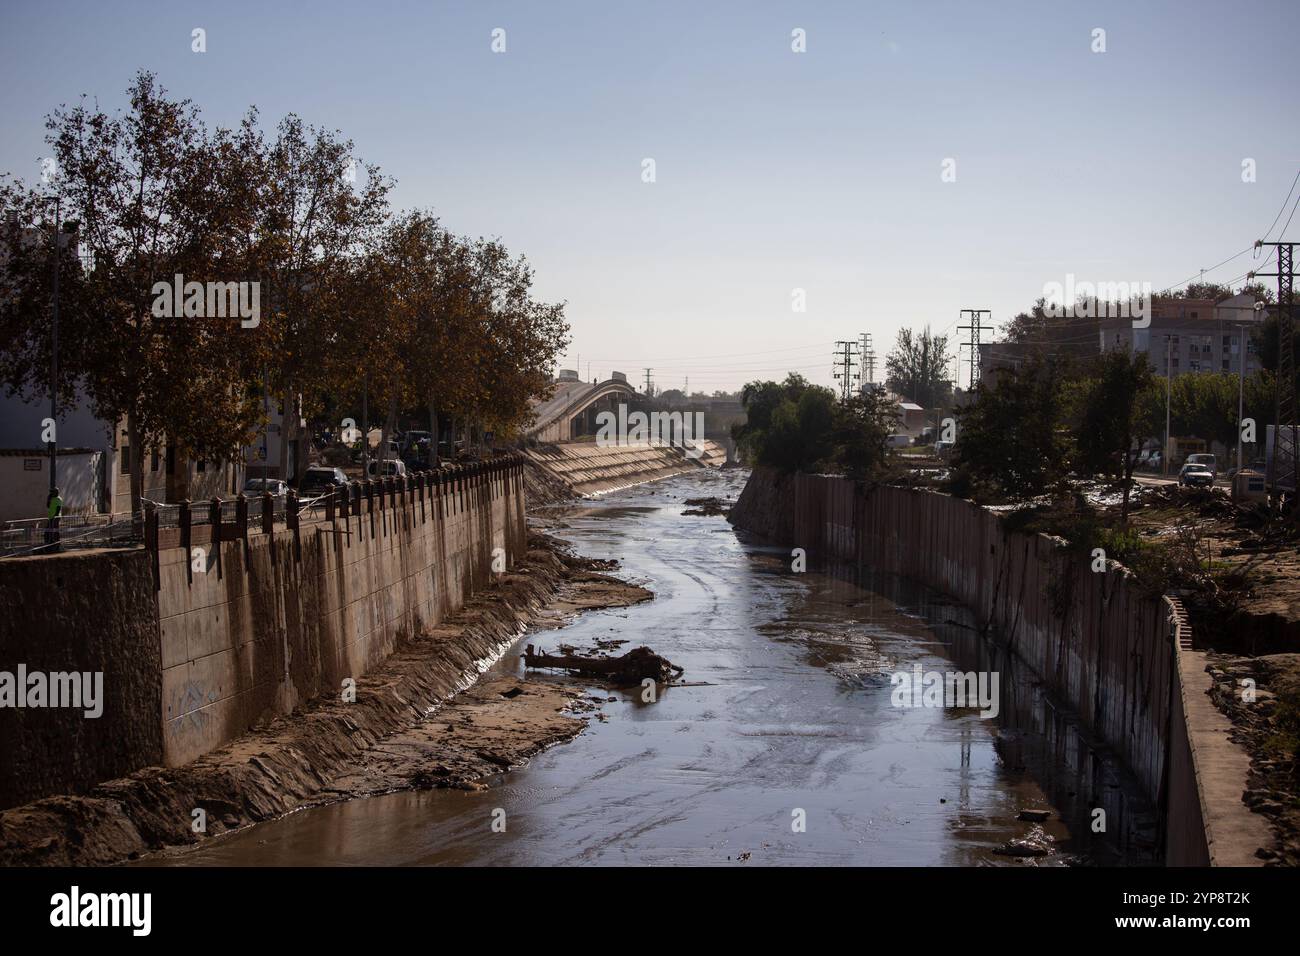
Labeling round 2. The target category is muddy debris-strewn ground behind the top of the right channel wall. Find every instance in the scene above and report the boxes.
[1006,485,1300,865]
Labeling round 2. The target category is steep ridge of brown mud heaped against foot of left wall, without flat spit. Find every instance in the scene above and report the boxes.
[0,549,589,866]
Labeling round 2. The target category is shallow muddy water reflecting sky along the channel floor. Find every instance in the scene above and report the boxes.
[168,471,1160,866]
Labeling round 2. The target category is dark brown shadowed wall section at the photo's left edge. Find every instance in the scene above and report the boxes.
[0,550,163,808]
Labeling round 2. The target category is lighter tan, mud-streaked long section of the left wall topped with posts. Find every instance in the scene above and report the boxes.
[157,460,527,766]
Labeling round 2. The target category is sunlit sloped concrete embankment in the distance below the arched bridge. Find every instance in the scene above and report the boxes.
[524,442,727,496]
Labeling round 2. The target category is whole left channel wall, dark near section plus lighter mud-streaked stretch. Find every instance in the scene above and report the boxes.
[0,457,528,809]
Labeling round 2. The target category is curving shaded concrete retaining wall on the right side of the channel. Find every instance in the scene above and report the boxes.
[729,470,1270,865]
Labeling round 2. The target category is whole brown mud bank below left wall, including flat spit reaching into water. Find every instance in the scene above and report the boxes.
[0,536,650,866]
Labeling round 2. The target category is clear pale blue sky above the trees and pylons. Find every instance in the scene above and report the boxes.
[0,0,1300,392]
